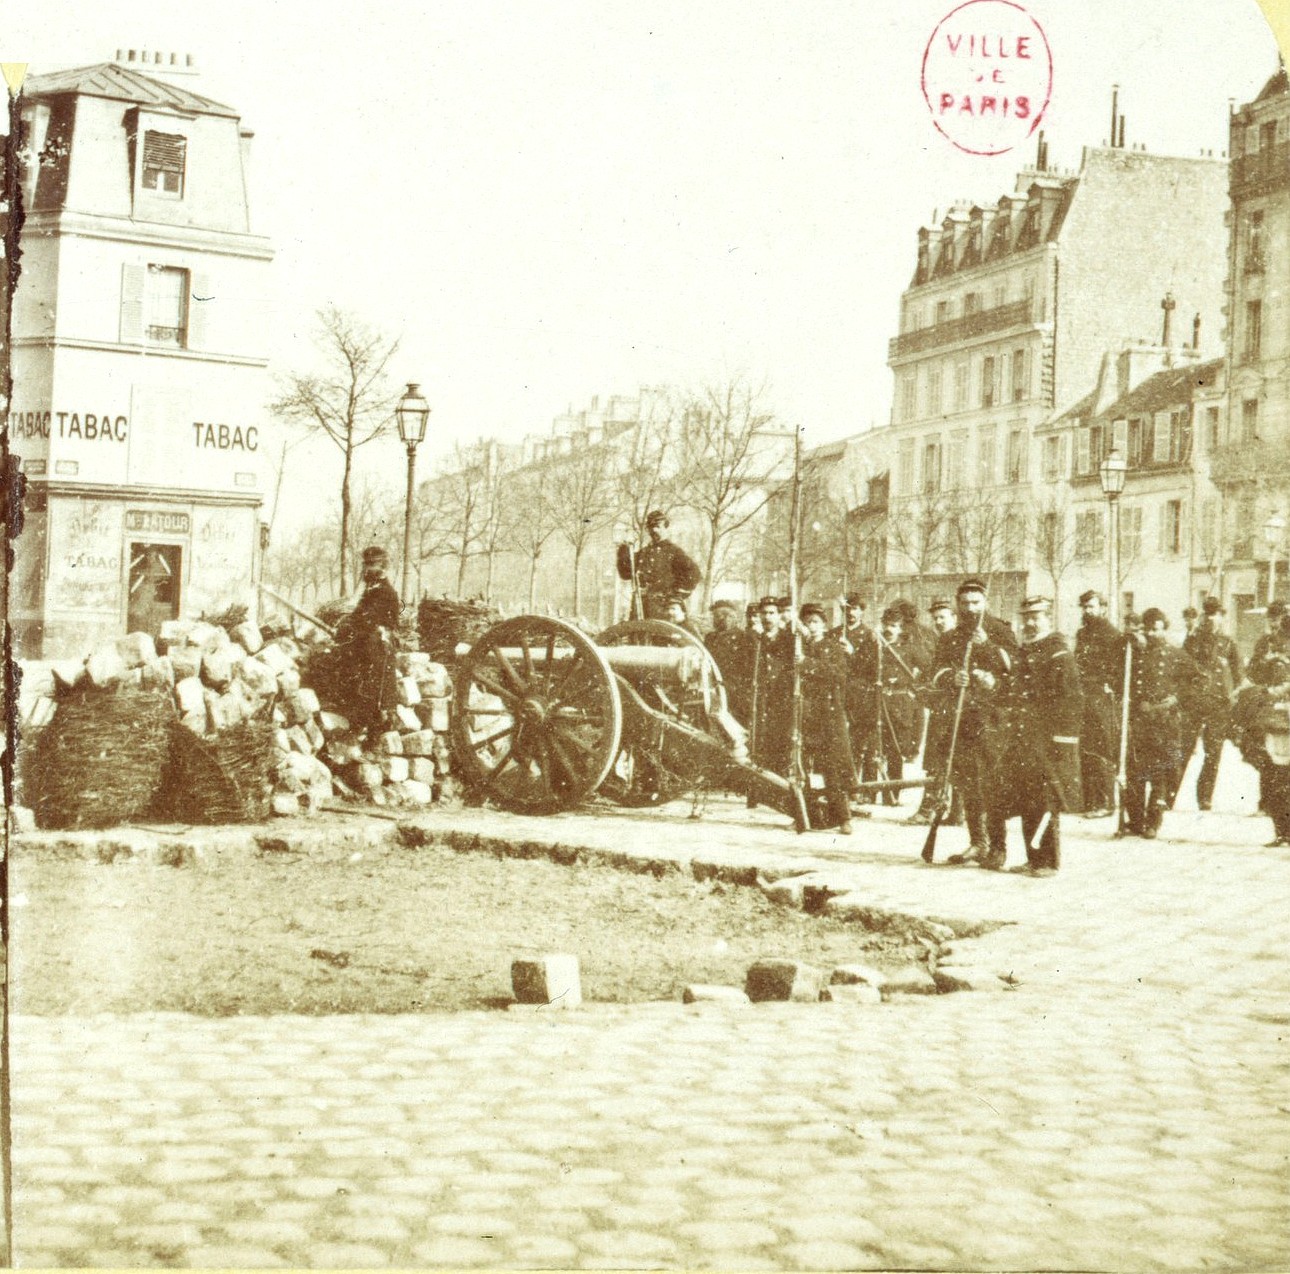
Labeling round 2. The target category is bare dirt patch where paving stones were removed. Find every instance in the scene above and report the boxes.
[10,846,925,1015]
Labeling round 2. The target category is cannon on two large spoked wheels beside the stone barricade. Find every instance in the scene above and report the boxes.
[453,615,804,830]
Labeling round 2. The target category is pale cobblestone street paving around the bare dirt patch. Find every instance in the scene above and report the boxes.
[12,747,1290,1270]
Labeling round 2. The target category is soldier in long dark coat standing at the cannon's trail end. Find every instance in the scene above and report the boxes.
[801,602,854,836]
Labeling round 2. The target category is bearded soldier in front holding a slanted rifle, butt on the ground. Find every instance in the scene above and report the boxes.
[934,579,1017,870]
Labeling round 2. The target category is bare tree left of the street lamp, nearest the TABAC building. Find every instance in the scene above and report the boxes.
[271,306,399,592]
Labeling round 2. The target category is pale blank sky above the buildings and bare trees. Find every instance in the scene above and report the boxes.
[0,0,1277,521]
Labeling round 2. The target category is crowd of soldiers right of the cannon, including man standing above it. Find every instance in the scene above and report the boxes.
[618,513,1290,876]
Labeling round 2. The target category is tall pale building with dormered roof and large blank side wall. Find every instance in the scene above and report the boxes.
[885,142,1227,615]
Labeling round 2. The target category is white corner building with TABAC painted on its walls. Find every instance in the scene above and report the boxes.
[6,52,272,658]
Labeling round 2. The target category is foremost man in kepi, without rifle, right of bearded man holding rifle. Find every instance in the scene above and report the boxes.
[1007,597,1082,876]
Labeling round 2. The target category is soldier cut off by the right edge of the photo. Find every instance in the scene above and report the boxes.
[1235,603,1290,848]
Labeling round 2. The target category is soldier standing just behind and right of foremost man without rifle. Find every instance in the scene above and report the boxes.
[1075,588,1125,819]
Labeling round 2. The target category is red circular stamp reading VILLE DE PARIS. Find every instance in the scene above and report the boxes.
[922,0,1053,155]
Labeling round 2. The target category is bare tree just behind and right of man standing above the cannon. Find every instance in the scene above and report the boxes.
[677,378,792,605]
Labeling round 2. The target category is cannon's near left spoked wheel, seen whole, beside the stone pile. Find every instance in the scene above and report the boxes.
[453,615,623,814]
